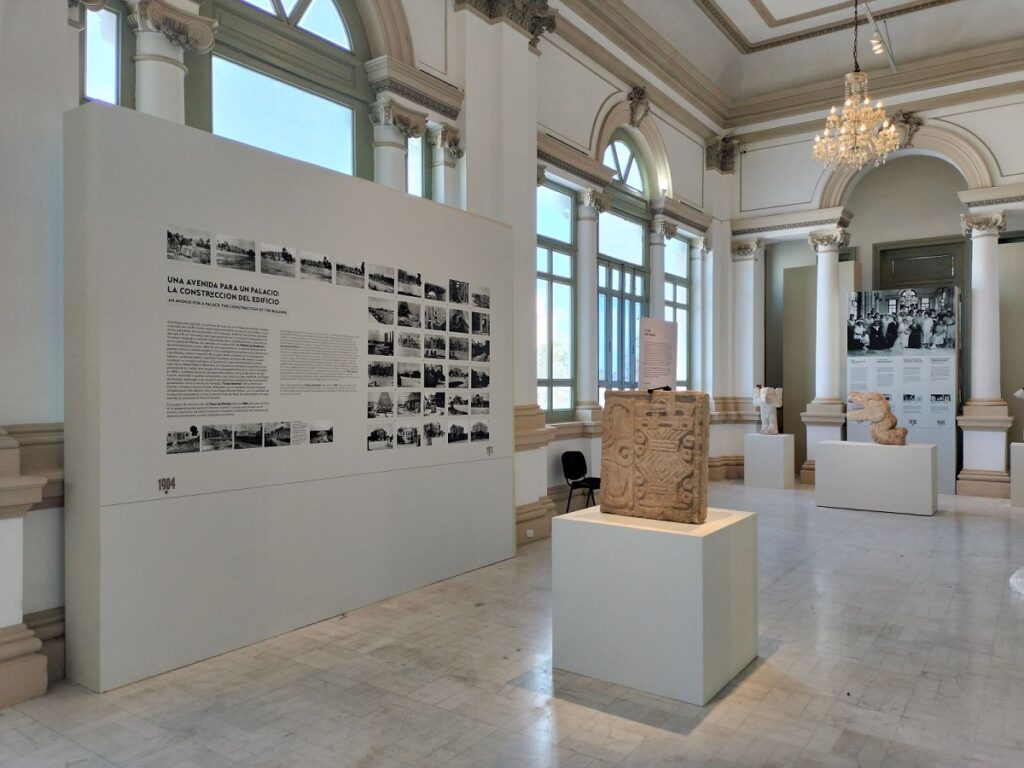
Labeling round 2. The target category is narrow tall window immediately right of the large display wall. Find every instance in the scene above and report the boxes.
[537,186,575,420]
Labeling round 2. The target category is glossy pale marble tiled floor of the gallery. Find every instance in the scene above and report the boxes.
[0,479,1024,768]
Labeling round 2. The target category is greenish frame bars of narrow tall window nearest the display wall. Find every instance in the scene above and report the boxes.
[535,181,579,424]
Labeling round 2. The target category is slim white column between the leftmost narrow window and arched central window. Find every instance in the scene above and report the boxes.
[575,189,609,422]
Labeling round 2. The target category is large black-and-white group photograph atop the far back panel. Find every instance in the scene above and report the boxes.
[846,287,958,356]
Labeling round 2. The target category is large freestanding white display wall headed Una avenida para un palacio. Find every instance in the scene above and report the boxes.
[65,104,515,690]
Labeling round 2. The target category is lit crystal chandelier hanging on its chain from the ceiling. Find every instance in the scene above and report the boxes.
[814,0,900,170]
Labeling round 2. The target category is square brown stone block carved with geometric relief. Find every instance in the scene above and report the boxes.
[601,391,711,523]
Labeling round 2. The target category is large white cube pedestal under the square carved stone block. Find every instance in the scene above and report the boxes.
[552,507,758,706]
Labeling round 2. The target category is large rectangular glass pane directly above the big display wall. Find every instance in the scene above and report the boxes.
[213,56,352,174]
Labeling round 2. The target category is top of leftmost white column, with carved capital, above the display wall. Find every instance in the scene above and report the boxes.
[128,0,217,124]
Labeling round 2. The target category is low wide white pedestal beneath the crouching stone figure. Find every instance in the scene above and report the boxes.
[814,440,939,515]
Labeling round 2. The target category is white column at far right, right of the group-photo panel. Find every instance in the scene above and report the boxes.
[956,211,1013,498]
